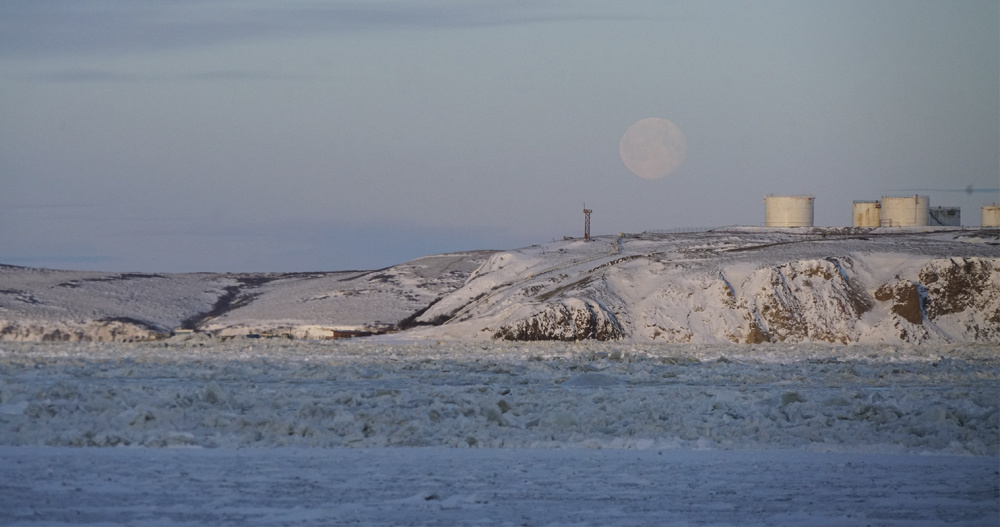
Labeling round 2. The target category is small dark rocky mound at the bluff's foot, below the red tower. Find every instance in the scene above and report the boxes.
[493,298,623,341]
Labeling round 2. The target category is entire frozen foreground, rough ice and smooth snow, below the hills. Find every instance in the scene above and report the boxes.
[0,337,1000,525]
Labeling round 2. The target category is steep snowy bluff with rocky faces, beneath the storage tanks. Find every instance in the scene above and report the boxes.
[406,228,1000,343]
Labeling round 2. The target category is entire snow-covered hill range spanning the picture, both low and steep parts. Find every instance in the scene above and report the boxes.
[0,228,1000,344]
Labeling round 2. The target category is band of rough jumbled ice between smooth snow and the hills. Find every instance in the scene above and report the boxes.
[0,338,1000,455]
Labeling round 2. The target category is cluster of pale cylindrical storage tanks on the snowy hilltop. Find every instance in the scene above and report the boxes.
[764,194,1000,227]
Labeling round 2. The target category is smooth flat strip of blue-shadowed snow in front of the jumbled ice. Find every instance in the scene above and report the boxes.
[0,447,1000,526]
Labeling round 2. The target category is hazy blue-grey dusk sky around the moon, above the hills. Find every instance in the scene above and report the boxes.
[0,0,1000,272]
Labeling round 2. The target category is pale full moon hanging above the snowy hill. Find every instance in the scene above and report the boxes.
[618,117,687,179]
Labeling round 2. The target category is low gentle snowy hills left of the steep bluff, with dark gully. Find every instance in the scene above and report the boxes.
[0,251,492,341]
